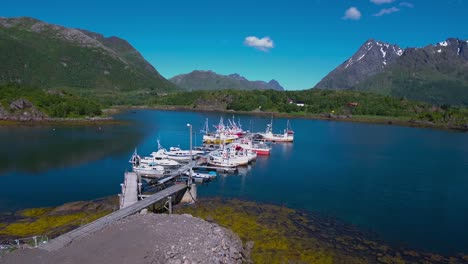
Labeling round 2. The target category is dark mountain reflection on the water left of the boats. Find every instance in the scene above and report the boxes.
[0,125,143,176]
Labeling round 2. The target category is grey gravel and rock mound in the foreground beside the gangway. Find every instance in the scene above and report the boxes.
[0,213,253,264]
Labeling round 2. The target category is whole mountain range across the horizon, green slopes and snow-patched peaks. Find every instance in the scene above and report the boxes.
[0,17,468,106]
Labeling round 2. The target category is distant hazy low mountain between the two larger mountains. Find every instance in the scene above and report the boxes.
[169,71,284,91]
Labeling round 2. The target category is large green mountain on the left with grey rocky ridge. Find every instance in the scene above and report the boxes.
[0,17,178,99]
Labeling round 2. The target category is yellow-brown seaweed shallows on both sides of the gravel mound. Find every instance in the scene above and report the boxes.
[4,197,468,264]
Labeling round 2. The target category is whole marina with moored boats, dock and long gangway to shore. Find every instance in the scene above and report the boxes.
[0,118,293,251]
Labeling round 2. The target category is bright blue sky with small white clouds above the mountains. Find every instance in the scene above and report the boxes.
[0,0,468,90]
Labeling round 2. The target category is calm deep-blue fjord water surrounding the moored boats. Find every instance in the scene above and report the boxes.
[0,110,468,254]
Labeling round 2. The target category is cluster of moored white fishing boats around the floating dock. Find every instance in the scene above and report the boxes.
[119,117,294,209]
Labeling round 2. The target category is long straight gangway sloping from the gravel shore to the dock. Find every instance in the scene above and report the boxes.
[39,184,187,251]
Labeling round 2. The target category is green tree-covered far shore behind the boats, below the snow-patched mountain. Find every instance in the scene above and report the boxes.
[151,89,468,126]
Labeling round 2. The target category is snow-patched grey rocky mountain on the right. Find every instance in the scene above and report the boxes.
[314,38,468,105]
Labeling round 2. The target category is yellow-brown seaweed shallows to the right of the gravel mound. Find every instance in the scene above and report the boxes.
[176,198,468,264]
